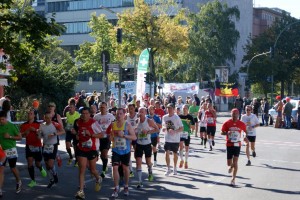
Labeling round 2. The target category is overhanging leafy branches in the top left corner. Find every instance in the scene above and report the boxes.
[0,0,64,74]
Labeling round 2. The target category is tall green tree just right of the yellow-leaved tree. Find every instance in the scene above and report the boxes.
[189,1,240,81]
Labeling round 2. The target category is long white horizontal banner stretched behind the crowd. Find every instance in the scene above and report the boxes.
[163,83,199,94]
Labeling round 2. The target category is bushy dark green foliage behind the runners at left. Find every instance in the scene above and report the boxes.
[6,39,78,115]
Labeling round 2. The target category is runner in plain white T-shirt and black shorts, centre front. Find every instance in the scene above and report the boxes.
[162,103,183,176]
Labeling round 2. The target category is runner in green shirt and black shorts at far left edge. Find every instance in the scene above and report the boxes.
[0,111,22,194]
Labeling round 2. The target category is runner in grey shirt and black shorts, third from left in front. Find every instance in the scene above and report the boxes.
[39,112,65,188]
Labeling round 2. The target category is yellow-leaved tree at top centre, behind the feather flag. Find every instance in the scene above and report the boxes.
[118,0,188,90]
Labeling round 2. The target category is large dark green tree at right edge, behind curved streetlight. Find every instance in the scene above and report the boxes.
[241,15,300,96]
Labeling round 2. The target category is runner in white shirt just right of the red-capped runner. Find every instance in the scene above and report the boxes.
[241,106,259,166]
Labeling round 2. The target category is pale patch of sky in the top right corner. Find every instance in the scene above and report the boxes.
[253,0,300,19]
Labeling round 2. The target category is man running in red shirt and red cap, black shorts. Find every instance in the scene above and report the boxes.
[221,108,247,186]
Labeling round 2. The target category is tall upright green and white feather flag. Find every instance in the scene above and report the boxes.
[135,49,149,99]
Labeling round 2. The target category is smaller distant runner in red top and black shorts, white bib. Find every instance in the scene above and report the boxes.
[205,103,217,151]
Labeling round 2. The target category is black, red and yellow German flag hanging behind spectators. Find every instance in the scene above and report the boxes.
[215,81,239,97]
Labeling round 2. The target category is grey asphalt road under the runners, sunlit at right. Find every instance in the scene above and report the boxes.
[3,117,300,200]
